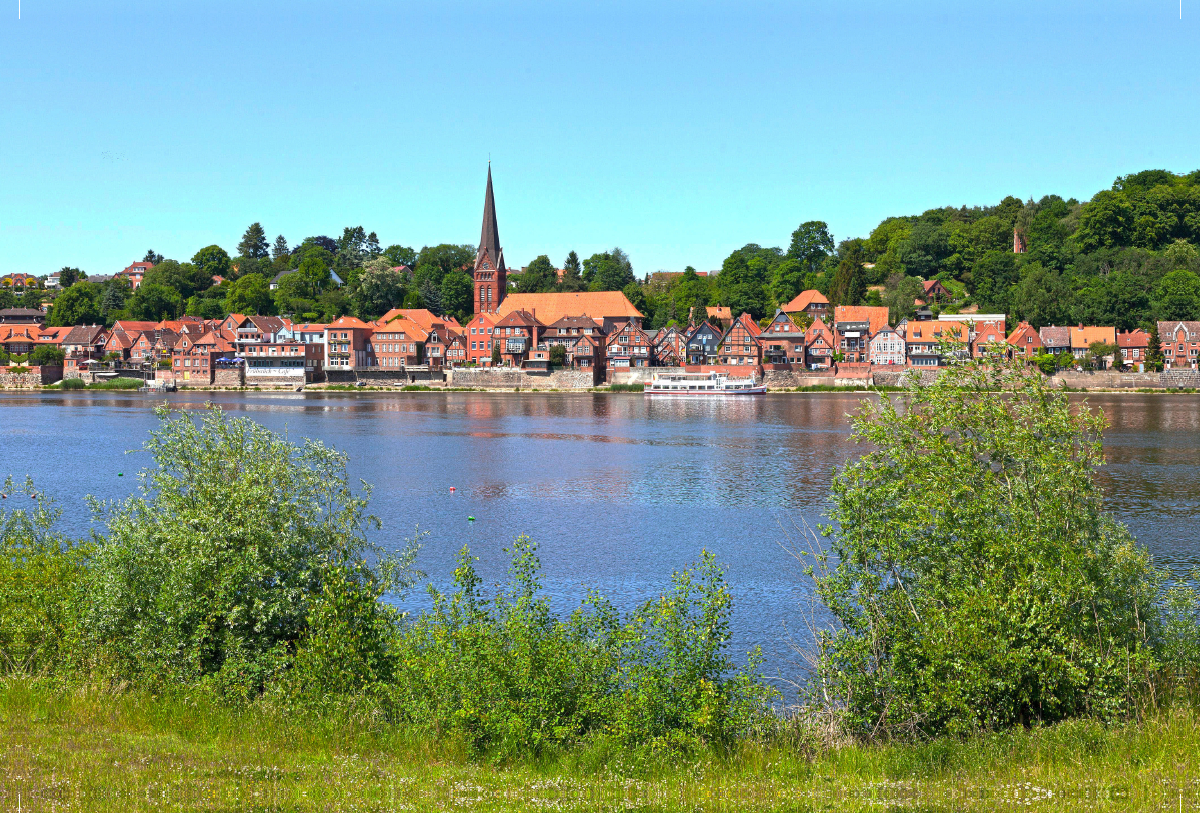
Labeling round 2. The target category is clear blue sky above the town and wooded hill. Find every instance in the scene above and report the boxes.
[0,0,1200,276]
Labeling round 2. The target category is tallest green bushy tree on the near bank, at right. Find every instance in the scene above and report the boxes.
[810,360,1158,737]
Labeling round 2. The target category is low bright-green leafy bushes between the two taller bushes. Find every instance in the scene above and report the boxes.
[389,537,773,758]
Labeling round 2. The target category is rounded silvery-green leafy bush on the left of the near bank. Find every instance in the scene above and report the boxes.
[86,408,416,695]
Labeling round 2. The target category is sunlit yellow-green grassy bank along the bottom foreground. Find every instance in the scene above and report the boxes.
[0,680,1200,812]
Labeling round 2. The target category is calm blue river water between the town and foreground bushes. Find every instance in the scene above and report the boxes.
[0,392,1200,678]
